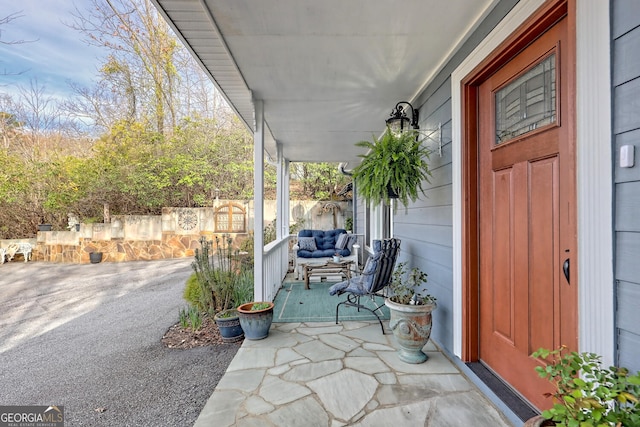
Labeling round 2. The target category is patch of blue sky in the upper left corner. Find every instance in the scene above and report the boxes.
[0,0,106,97]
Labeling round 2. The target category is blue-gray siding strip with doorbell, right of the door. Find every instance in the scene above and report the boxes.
[612,0,640,371]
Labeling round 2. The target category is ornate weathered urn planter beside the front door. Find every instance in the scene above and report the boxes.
[384,298,436,364]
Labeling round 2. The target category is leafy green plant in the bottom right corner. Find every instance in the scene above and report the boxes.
[525,346,640,427]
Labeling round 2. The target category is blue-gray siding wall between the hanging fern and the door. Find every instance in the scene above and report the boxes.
[394,0,517,351]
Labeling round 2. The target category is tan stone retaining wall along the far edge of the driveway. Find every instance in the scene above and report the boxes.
[0,200,351,263]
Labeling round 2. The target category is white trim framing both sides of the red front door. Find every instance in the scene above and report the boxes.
[451,0,614,366]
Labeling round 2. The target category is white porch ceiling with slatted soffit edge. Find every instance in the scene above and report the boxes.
[152,0,497,167]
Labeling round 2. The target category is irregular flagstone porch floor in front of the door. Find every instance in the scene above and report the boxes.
[195,322,512,427]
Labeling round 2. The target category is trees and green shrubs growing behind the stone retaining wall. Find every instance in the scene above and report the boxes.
[0,0,324,238]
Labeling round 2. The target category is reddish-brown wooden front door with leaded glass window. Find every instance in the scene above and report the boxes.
[477,14,577,408]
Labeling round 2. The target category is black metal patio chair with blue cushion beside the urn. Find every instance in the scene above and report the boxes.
[329,239,400,334]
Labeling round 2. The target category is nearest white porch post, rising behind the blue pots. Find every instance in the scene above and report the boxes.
[253,99,265,301]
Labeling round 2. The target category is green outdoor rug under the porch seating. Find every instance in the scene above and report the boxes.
[273,282,389,322]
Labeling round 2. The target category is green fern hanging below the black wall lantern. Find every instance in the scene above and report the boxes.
[353,126,431,211]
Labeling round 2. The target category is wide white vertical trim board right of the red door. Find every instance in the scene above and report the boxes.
[572,0,616,366]
